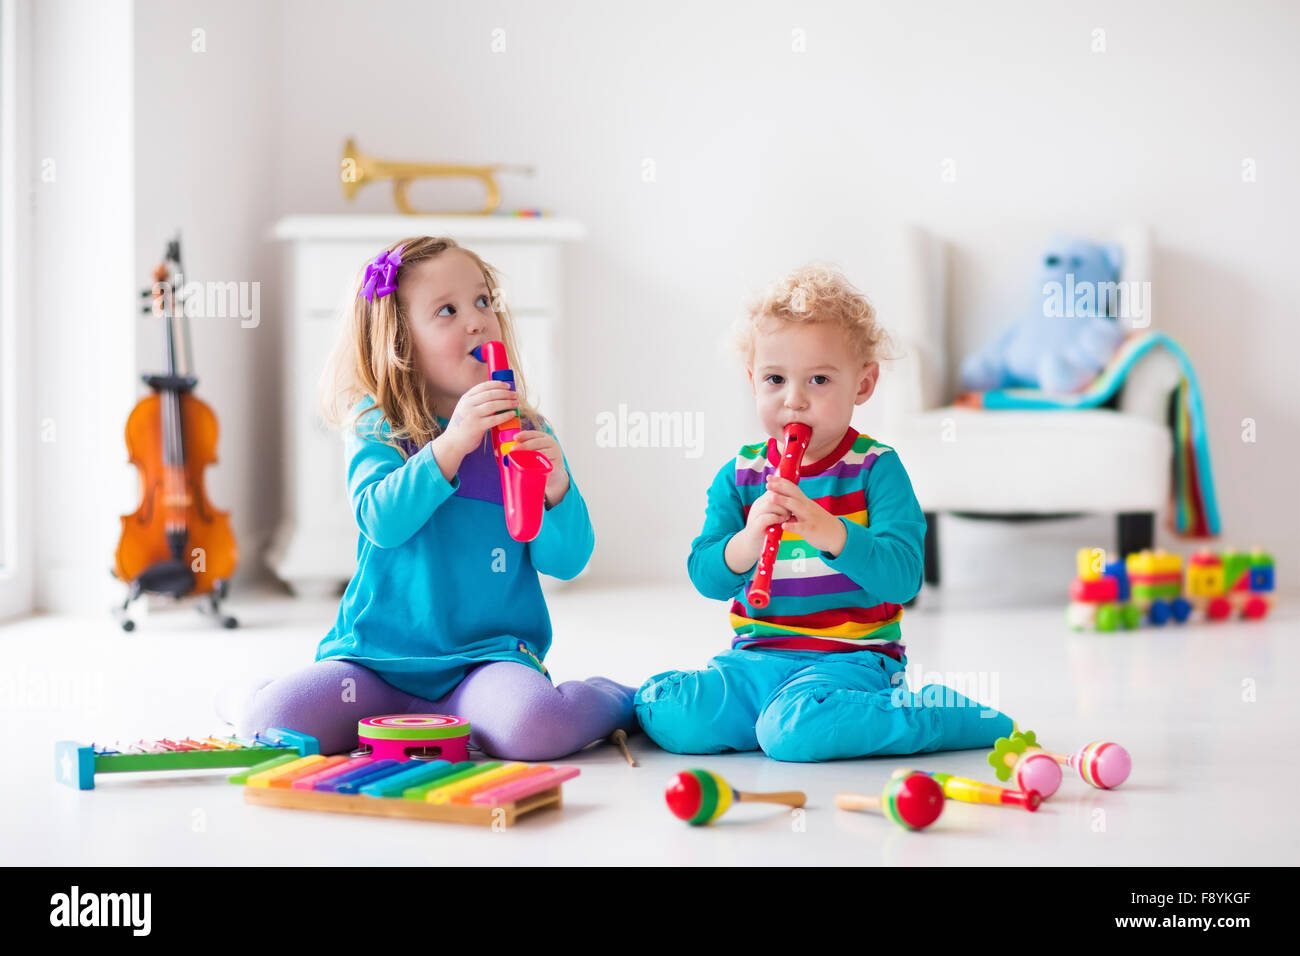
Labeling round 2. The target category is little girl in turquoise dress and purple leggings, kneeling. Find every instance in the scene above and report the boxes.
[217,237,637,760]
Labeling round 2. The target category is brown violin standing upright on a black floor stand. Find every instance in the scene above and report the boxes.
[113,235,239,631]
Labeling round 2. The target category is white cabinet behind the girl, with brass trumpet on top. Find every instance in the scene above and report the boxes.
[267,216,585,596]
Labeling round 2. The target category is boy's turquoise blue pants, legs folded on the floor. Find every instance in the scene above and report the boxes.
[634,649,1013,762]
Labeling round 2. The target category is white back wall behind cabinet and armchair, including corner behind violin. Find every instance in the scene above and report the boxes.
[116,0,1300,598]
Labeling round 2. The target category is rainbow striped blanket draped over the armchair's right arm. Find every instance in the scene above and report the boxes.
[965,332,1219,537]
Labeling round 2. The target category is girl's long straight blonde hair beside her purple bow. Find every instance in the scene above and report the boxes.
[320,235,545,454]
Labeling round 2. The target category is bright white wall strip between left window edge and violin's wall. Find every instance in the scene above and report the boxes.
[31,0,135,614]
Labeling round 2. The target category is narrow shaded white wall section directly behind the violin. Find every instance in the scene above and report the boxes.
[132,0,286,598]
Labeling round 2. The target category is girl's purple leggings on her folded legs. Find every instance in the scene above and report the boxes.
[231,661,637,761]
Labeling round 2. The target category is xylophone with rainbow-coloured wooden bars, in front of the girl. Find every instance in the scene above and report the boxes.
[230,753,579,826]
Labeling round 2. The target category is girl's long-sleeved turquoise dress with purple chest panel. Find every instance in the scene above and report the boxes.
[316,399,595,700]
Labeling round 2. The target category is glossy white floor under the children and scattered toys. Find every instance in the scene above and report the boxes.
[0,585,1300,866]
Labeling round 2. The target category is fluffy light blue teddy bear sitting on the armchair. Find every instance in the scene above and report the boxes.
[962,237,1125,393]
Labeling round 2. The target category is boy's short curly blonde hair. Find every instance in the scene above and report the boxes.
[733,263,894,367]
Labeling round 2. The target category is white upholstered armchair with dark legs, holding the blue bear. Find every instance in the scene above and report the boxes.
[854,226,1178,584]
